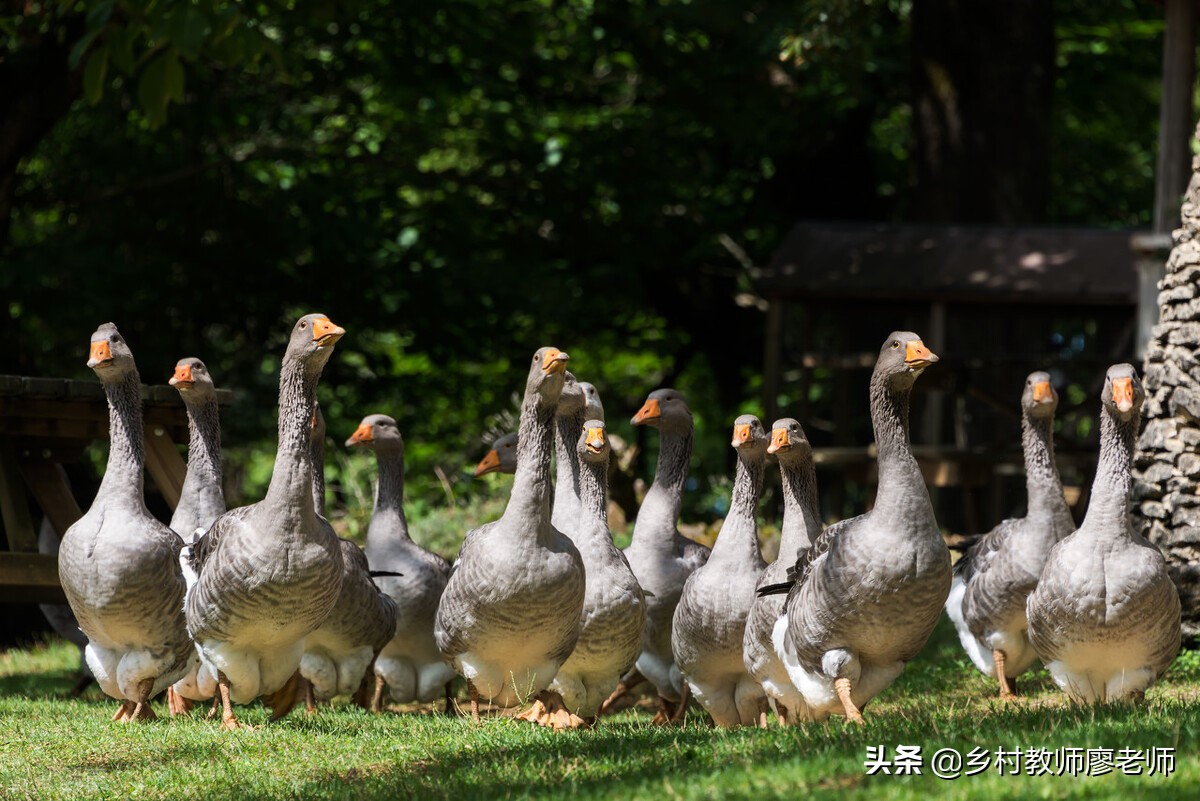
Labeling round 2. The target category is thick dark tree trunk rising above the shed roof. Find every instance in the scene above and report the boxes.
[912,0,1055,224]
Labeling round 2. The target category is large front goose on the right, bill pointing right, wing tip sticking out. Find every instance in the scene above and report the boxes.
[758,331,950,723]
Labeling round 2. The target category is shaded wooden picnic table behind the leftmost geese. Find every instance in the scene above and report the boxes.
[0,375,233,603]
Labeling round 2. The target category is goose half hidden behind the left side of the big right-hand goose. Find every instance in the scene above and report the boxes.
[743,417,821,725]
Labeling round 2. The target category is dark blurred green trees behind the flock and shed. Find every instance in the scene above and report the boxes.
[0,0,1163,522]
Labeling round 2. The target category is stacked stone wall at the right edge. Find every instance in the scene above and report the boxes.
[1133,130,1200,642]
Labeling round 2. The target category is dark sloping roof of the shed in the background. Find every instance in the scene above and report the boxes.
[756,222,1138,306]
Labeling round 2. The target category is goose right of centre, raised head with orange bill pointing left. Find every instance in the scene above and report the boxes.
[601,389,709,724]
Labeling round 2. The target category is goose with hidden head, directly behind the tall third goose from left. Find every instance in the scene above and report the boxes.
[300,404,396,712]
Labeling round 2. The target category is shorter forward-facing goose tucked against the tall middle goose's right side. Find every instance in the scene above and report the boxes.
[550,420,646,723]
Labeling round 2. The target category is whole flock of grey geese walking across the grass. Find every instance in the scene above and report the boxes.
[46,314,1180,729]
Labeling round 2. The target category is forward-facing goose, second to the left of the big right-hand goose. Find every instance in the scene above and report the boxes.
[671,415,769,728]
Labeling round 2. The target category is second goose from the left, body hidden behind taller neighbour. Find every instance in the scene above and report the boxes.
[167,356,226,715]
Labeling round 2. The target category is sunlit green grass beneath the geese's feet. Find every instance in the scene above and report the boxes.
[0,621,1200,801]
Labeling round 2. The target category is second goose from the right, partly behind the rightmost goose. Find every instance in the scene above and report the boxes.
[946,372,1075,699]
